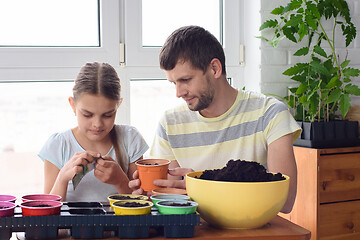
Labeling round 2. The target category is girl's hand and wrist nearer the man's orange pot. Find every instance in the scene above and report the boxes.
[94,155,129,193]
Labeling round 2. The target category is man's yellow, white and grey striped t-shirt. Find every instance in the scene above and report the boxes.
[150,90,301,171]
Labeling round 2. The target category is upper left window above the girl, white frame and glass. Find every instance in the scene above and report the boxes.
[0,0,120,81]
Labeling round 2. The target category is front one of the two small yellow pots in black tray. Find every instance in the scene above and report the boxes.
[111,200,154,215]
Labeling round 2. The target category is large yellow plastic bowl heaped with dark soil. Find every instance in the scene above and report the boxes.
[186,171,290,229]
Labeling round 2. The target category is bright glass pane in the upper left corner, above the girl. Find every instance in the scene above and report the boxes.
[0,0,100,46]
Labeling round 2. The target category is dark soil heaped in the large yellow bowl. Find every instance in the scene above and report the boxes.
[199,159,285,182]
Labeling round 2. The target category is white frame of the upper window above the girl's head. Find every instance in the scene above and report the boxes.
[0,0,120,81]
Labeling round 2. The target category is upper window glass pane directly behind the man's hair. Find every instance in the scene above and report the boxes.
[142,0,222,47]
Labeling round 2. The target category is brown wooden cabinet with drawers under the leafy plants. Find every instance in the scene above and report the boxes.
[279,147,360,240]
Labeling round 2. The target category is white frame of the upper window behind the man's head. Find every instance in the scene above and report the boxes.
[125,0,243,67]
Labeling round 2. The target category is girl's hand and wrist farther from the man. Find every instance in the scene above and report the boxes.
[59,151,100,183]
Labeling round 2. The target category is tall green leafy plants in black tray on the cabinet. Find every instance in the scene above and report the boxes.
[260,0,360,122]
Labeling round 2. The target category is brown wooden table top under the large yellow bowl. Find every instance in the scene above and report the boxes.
[17,216,311,240]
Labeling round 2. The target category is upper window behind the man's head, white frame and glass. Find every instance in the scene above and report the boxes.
[124,0,243,66]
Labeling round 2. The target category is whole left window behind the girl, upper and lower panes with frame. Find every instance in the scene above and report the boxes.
[0,0,120,201]
